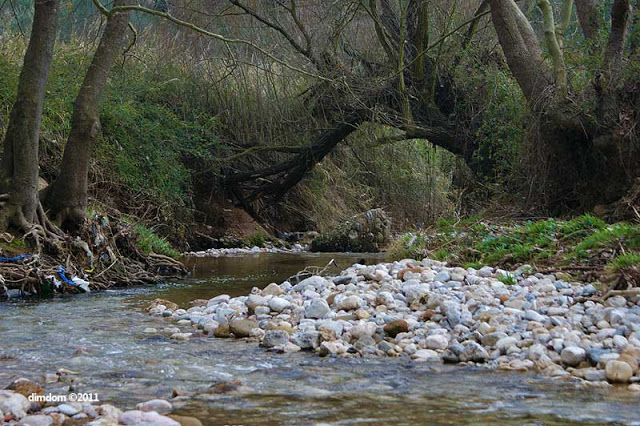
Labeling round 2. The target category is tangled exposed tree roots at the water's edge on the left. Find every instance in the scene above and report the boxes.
[0,204,188,299]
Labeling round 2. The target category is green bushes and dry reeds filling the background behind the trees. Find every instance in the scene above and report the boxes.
[0,0,640,248]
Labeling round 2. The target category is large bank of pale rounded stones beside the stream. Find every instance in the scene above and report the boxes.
[151,259,640,392]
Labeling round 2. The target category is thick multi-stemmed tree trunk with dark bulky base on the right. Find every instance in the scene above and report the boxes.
[489,0,638,208]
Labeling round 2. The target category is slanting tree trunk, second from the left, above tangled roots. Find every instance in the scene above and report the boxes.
[46,0,130,231]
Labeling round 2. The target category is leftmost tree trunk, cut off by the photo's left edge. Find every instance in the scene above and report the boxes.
[0,0,58,231]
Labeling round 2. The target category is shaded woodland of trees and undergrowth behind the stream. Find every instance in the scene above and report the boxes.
[0,0,640,251]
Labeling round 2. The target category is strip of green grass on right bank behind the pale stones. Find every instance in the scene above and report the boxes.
[388,214,640,274]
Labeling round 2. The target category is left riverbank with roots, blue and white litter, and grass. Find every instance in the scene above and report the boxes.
[0,213,188,301]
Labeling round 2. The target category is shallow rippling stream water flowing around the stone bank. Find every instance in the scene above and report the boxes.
[0,254,640,425]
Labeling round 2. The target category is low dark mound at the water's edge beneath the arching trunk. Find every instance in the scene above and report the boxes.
[310,209,391,253]
